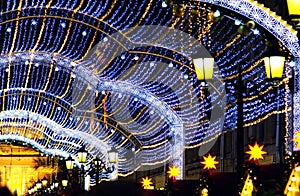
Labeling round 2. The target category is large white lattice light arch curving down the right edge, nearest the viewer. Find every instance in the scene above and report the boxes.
[200,0,300,154]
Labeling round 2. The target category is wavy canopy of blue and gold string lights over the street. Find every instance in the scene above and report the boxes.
[0,0,287,175]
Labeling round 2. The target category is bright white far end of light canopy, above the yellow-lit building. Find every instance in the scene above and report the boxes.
[0,110,108,157]
